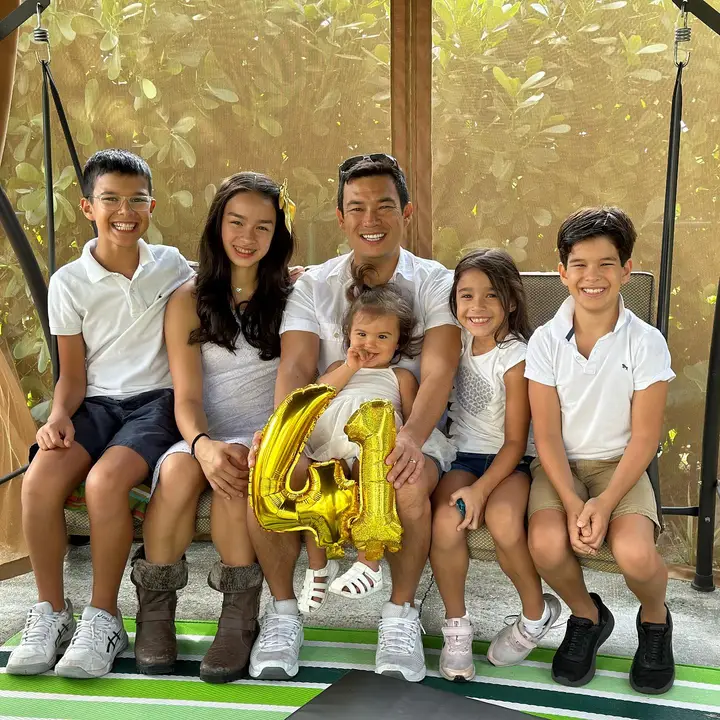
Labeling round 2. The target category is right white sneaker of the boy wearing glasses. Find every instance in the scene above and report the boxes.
[55,605,128,678]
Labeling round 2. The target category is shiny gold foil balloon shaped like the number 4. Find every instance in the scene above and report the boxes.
[248,385,359,558]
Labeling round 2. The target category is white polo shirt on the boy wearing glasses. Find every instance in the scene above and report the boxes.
[48,239,194,398]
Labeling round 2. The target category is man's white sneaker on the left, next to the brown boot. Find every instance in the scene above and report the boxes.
[250,598,303,680]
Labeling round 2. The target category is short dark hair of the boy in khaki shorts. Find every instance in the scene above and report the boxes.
[558,207,637,265]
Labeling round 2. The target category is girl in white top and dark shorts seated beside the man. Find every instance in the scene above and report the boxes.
[430,250,560,680]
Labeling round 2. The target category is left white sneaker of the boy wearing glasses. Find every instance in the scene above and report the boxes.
[5,600,75,675]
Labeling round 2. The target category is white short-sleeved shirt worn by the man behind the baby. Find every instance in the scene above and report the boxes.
[280,248,457,381]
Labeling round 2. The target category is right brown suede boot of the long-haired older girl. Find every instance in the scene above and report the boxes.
[200,561,263,683]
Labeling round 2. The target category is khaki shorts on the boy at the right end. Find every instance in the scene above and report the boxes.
[528,458,662,536]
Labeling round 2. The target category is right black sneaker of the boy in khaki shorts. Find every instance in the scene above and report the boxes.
[630,606,675,695]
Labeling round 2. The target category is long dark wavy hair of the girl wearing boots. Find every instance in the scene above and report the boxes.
[189,172,295,360]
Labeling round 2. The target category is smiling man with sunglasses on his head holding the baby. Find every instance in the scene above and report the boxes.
[249,153,460,682]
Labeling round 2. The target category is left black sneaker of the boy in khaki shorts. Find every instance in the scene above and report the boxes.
[552,593,615,687]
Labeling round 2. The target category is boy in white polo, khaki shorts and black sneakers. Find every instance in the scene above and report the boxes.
[525,207,675,694]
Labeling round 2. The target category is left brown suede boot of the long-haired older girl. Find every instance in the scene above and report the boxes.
[130,546,188,675]
